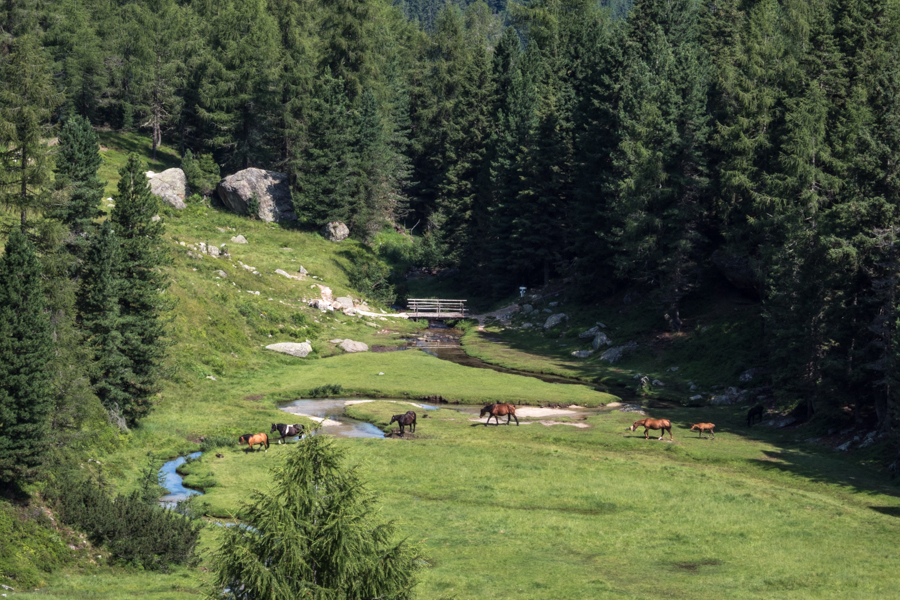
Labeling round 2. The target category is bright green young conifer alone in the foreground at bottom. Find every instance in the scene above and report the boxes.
[210,435,418,600]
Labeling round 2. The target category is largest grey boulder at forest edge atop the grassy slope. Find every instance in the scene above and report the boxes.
[216,168,297,223]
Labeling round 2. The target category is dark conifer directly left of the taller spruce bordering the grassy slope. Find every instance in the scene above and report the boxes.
[78,221,134,424]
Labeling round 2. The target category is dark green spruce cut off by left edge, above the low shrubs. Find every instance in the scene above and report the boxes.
[0,228,53,482]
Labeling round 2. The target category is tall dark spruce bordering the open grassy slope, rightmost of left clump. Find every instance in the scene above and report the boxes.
[110,154,168,425]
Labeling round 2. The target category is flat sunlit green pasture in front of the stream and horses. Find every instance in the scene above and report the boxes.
[158,402,900,599]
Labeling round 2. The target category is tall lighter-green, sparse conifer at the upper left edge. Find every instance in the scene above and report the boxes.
[0,35,60,228]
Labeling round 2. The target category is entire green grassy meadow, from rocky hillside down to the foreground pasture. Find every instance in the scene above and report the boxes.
[7,133,900,600]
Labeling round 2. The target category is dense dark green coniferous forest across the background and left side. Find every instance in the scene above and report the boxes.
[0,0,900,592]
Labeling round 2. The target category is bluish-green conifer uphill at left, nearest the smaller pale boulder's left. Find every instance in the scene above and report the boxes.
[56,115,104,245]
